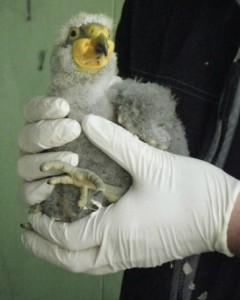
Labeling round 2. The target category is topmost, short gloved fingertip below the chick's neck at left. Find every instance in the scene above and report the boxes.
[23,96,70,123]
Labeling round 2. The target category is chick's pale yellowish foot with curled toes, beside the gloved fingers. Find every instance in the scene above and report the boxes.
[40,161,105,208]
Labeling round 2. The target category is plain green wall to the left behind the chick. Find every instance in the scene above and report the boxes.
[0,0,123,300]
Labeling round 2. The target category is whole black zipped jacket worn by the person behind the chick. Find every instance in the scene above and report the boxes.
[116,0,240,300]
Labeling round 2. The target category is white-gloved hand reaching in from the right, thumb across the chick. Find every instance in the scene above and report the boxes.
[22,115,240,274]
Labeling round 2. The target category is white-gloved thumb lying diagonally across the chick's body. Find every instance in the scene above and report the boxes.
[82,115,163,179]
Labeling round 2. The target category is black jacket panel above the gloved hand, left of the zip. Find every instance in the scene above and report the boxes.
[116,0,240,158]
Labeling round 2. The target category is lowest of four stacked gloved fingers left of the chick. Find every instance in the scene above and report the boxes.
[17,179,55,207]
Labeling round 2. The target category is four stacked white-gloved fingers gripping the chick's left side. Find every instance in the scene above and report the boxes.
[17,97,81,206]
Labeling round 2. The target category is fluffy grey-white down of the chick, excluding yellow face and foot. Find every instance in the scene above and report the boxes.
[34,13,188,222]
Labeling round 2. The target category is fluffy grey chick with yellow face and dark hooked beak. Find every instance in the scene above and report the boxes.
[24,13,188,222]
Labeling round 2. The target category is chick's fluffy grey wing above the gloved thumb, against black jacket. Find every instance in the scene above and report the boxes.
[109,79,189,155]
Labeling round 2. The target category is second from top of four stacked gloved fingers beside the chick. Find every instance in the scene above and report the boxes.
[18,119,81,153]
